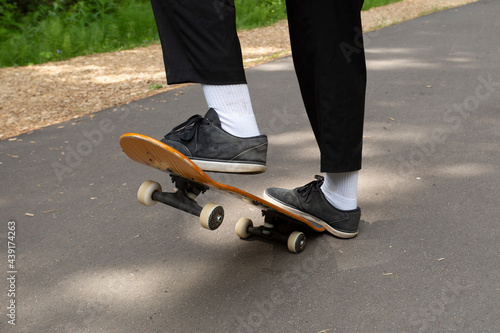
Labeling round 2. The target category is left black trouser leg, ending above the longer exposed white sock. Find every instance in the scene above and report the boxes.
[151,0,246,85]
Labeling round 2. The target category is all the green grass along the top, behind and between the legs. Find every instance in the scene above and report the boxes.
[0,0,401,67]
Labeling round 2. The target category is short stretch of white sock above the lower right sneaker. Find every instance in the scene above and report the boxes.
[321,171,359,210]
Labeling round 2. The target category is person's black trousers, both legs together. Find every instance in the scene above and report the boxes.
[151,0,366,172]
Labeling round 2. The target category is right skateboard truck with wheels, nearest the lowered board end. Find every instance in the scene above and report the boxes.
[235,210,306,253]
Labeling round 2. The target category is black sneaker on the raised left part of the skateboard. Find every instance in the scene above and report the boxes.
[161,109,267,173]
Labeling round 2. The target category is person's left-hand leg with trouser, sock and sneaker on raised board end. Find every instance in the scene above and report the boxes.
[151,0,267,173]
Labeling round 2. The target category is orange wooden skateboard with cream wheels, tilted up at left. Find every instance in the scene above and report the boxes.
[120,133,325,253]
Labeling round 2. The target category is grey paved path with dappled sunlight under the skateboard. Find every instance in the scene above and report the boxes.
[0,0,500,332]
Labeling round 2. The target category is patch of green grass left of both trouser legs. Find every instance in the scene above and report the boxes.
[0,0,158,67]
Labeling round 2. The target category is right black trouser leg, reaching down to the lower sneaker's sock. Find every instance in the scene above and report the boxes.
[287,0,366,172]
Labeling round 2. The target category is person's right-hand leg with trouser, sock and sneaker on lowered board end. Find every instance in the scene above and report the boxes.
[264,0,366,233]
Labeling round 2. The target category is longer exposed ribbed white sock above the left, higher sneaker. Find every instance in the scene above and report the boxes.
[202,84,260,138]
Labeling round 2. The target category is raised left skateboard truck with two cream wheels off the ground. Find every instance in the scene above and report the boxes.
[137,175,224,230]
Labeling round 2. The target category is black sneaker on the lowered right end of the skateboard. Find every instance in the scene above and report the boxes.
[264,176,361,238]
